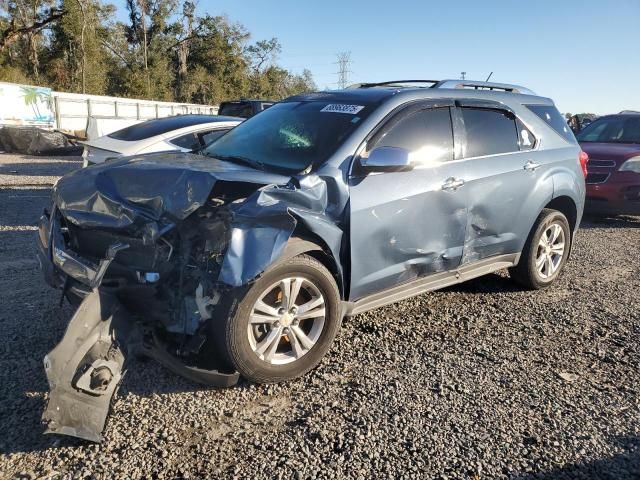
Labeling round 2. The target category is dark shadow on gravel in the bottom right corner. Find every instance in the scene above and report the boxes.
[510,437,640,480]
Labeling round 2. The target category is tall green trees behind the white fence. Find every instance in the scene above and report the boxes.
[0,0,316,104]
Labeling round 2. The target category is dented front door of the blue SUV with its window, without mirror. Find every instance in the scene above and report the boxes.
[350,102,467,300]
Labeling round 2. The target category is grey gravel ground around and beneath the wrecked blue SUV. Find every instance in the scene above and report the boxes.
[0,155,640,480]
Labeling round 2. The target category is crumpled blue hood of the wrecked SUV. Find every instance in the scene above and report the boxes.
[53,153,290,229]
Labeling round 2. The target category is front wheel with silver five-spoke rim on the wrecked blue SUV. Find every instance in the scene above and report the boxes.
[213,255,342,383]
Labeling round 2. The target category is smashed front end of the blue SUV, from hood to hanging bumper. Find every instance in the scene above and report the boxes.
[39,156,342,442]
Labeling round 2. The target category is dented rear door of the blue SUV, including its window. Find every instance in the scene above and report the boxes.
[455,101,553,265]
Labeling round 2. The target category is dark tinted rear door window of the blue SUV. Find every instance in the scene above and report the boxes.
[462,108,520,157]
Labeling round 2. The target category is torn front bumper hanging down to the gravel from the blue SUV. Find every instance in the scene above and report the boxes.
[38,208,239,442]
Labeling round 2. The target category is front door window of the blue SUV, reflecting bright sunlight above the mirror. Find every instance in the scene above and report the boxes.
[369,108,453,163]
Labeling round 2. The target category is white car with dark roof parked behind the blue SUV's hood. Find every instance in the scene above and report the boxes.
[82,115,244,167]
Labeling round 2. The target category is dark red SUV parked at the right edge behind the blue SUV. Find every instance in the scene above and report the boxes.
[577,112,640,215]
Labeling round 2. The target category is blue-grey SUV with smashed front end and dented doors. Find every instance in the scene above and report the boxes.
[39,80,586,440]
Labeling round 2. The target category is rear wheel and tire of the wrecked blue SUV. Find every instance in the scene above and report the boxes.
[509,208,571,290]
